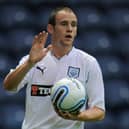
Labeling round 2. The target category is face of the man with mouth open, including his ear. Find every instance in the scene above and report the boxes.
[47,10,77,46]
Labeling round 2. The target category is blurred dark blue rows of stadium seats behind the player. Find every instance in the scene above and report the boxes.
[0,0,129,129]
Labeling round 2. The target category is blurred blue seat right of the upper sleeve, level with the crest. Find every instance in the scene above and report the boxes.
[96,55,124,80]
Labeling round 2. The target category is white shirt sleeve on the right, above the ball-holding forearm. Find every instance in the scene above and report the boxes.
[86,59,105,110]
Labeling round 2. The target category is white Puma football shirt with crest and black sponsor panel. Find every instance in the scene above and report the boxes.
[11,47,105,129]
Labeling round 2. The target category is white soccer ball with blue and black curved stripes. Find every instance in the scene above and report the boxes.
[51,78,86,113]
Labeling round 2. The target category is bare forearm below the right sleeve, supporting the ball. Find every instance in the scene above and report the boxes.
[78,107,105,121]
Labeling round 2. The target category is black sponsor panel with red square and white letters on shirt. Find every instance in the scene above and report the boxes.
[31,84,53,96]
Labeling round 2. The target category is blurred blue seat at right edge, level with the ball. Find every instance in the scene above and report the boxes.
[105,79,129,111]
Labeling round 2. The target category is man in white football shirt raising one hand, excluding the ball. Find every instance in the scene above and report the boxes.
[4,7,105,129]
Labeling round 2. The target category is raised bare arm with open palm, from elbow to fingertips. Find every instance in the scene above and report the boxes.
[3,31,50,90]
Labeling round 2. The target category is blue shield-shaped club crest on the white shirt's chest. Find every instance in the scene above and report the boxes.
[67,66,80,78]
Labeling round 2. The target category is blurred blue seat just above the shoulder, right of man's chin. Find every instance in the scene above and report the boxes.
[75,31,113,55]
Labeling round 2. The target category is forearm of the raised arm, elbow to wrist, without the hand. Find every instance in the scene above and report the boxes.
[4,60,34,91]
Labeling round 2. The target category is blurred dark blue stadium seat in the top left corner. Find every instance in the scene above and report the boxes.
[0,5,34,28]
